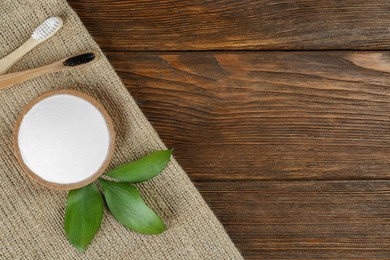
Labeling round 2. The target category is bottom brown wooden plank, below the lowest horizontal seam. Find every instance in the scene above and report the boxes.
[196,181,390,259]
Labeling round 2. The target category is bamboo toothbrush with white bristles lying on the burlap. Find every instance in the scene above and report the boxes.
[0,17,63,75]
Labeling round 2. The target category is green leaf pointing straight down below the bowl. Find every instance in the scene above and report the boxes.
[65,183,103,252]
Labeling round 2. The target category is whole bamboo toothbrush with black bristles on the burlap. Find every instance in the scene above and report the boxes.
[0,51,99,90]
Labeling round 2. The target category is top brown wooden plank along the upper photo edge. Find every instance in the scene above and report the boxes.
[69,0,390,51]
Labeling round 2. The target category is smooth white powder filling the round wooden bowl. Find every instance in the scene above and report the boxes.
[17,94,110,184]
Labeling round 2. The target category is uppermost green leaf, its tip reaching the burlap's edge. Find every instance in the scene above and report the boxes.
[106,150,172,183]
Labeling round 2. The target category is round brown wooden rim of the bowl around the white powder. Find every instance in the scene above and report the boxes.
[13,89,116,190]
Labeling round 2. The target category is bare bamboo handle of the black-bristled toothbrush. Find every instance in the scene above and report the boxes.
[0,61,64,90]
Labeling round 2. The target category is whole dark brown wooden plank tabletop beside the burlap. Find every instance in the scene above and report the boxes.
[70,0,390,259]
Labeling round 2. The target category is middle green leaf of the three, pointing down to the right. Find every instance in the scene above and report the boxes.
[99,178,165,234]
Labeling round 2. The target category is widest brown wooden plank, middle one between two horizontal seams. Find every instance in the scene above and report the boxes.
[107,52,390,181]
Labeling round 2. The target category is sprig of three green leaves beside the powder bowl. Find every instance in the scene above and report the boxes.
[65,150,172,252]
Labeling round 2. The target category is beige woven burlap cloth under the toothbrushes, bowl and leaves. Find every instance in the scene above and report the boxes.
[0,0,242,259]
